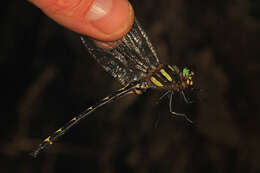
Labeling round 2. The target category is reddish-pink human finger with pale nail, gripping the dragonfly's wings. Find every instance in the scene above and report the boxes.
[29,0,134,41]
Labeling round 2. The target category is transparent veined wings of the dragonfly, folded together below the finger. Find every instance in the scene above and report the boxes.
[81,19,159,86]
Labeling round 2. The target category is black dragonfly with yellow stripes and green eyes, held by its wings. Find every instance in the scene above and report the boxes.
[31,18,195,157]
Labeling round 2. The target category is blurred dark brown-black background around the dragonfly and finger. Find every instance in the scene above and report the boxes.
[0,0,260,173]
